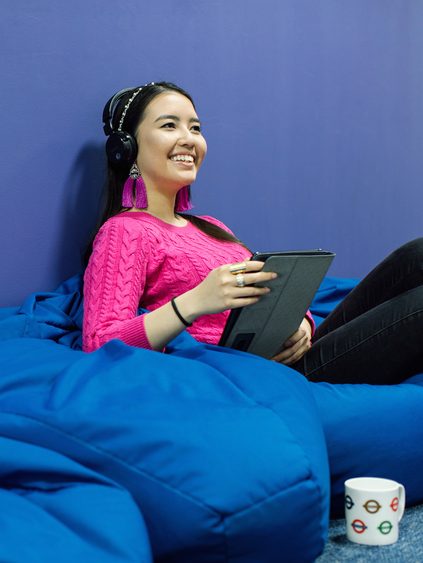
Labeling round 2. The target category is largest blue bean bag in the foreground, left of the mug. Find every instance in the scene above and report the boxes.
[0,335,329,563]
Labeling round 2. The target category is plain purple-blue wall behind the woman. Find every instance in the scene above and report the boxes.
[0,0,423,305]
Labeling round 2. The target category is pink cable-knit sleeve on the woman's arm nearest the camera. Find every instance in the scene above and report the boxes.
[83,218,152,352]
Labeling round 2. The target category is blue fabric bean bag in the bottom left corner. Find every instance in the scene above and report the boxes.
[0,436,152,563]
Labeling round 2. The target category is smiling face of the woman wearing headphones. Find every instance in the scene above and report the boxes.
[136,92,207,191]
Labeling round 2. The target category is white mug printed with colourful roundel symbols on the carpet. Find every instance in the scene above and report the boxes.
[345,477,405,545]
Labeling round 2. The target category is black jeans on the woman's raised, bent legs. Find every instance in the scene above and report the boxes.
[292,238,423,384]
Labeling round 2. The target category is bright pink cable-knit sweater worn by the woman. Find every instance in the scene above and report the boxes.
[83,211,314,352]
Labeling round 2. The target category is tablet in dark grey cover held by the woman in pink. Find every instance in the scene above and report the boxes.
[219,249,335,358]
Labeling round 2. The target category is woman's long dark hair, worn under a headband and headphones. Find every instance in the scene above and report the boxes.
[84,82,247,264]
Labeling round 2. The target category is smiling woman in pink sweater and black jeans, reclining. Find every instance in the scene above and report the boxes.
[83,82,423,383]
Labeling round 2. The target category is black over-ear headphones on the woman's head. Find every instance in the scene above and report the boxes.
[103,88,142,166]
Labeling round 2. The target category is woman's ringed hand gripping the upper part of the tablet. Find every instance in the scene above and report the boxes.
[178,260,277,322]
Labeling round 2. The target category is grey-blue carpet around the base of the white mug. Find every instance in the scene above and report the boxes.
[316,505,423,563]
